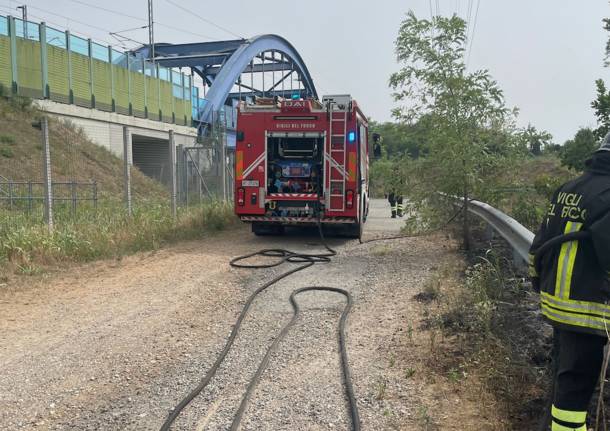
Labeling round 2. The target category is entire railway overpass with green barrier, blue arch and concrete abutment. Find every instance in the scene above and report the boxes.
[0,11,317,194]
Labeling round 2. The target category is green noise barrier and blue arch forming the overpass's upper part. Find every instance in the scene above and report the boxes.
[0,16,317,135]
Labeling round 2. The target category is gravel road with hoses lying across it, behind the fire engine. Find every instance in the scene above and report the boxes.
[0,200,455,430]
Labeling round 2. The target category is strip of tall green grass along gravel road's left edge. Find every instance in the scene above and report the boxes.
[0,201,235,277]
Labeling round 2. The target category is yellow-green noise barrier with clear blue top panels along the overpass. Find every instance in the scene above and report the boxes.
[0,16,193,126]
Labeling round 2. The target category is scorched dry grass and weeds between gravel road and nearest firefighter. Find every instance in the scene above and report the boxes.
[416,248,550,430]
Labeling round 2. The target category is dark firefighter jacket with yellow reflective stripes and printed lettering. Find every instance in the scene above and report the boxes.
[530,157,610,336]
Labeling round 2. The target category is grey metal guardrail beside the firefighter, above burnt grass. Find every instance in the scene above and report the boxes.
[468,200,534,263]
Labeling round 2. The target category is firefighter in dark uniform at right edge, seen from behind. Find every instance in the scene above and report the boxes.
[530,134,610,431]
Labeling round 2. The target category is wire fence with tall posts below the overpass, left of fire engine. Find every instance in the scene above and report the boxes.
[0,109,233,232]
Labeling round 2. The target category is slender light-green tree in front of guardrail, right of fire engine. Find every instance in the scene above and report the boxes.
[390,11,514,248]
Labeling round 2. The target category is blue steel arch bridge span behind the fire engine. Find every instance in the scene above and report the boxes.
[137,34,318,131]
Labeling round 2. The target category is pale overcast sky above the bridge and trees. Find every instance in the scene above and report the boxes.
[0,0,610,143]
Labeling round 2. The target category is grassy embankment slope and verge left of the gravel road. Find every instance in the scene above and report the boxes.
[0,97,235,282]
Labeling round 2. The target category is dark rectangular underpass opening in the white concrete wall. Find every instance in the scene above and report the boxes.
[131,135,171,186]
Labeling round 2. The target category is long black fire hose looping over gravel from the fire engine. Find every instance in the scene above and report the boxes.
[160,223,360,431]
